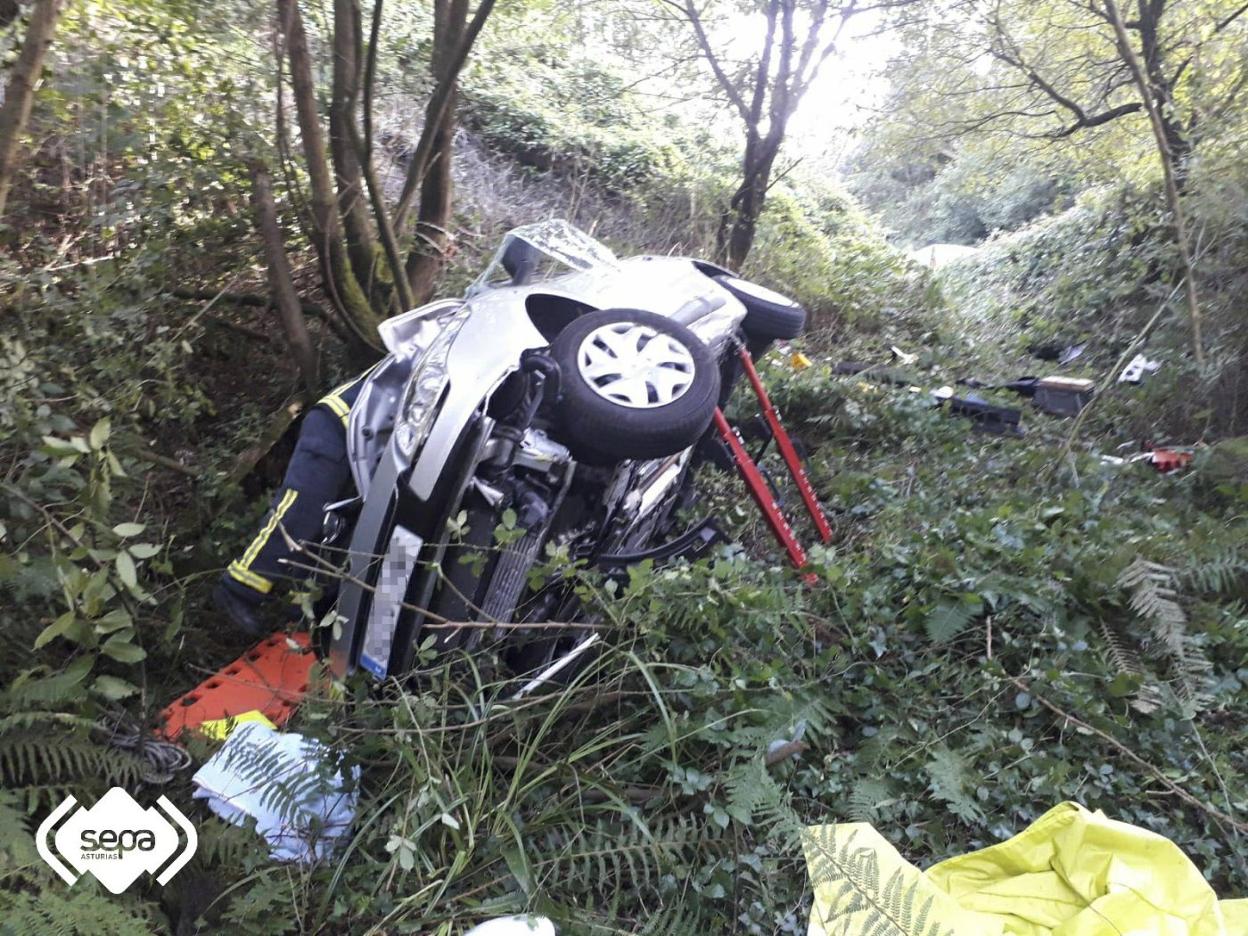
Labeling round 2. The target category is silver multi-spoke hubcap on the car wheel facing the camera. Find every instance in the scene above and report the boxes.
[577,322,695,409]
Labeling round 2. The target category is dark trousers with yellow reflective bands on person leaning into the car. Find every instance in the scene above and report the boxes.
[222,374,363,603]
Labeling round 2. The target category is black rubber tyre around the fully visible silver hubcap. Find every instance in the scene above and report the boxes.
[550,308,719,464]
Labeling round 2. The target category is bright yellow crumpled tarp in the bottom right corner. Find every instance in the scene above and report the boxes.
[804,802,1248,936]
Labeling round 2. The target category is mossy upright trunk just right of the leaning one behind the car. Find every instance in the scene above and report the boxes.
[329,0,376,296]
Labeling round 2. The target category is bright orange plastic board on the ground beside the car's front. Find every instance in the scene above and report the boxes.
[160,631,316,741]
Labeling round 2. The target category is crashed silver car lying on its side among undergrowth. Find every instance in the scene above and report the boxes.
[326,221,805,678]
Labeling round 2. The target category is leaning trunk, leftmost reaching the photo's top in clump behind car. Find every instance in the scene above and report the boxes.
[277,0,381,349]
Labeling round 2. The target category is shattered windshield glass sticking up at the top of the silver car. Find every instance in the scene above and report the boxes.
[468,218,618,296]
